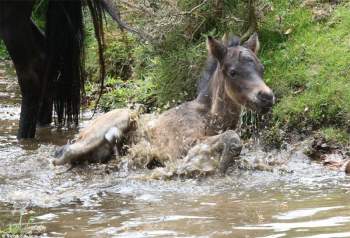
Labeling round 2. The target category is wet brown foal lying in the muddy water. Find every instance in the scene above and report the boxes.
[54,34,275,174]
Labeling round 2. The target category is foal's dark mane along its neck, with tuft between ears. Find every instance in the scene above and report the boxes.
[197,35,240,104]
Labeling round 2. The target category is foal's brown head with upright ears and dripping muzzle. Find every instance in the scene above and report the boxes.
[208,33,275,113]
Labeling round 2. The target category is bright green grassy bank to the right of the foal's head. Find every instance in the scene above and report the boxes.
[261,1,350,136]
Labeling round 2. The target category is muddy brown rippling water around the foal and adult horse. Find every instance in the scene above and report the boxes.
[0,61,350,238]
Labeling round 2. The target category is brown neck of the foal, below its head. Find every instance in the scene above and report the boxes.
[209,66,241,130]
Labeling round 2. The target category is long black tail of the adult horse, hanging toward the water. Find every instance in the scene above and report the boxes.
[45,0,105,125]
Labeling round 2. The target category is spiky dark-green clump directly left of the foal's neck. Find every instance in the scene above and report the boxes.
[145,41,206,107]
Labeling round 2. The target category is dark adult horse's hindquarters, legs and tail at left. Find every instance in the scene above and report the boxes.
[0,0,134,138]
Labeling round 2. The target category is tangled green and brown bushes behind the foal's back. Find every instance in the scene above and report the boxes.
[87,0,256,110]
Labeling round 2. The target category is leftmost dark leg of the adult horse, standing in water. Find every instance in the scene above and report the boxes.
[0,1,44,138]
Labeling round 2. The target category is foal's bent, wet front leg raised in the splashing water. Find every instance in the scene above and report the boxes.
[177,130,242,175]
